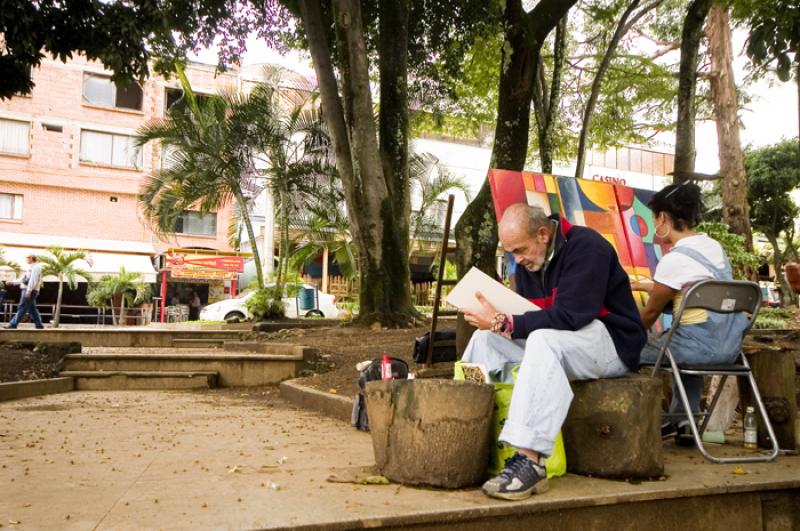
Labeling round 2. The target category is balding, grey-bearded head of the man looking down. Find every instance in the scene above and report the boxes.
[497,203,553,271]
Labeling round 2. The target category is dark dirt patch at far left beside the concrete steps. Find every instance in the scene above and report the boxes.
[0,343,66,382]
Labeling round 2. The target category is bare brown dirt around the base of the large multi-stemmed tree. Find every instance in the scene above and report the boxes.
[260,325,440,397]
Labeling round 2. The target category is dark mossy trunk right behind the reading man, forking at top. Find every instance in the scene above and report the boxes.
[456,0,577,352]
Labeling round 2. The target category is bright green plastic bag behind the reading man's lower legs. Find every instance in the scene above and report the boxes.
[454,361,567,478]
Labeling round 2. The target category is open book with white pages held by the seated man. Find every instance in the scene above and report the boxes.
[447,267,541,315]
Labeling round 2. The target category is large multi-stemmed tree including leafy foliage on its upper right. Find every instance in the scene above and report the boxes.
[290,0,492,324]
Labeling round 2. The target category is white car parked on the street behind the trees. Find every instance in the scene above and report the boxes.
[200,284,339,322]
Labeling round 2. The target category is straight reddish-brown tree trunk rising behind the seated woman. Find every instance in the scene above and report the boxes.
[706,4,753,251]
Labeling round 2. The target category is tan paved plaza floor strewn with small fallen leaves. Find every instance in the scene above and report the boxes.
[0,387,800,530]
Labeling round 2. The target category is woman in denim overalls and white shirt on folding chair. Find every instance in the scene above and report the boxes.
[631,184,747,446]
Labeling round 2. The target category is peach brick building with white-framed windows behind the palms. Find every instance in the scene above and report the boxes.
[0,58,252,322]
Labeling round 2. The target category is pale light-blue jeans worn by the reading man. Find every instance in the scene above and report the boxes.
[462,319,628,456]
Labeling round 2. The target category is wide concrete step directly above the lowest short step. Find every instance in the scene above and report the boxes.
[64,349,305,387]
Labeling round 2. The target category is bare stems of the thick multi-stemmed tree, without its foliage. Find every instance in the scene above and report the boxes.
[300,0,415,324]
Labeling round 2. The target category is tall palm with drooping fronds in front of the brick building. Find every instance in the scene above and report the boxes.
[137,69,276,287]
